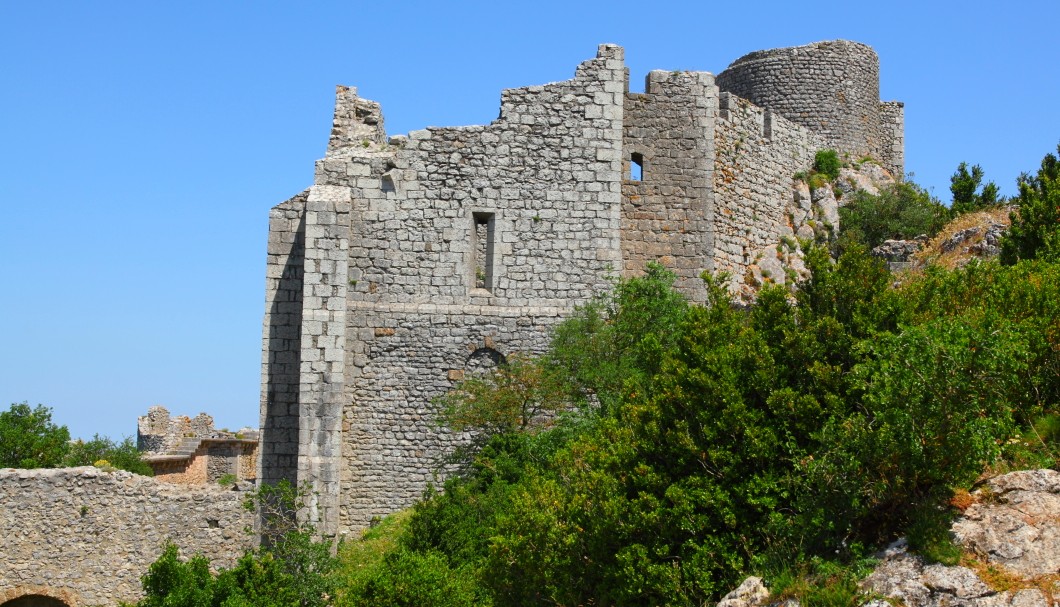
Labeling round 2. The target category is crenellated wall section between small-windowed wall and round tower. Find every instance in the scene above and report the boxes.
[714,92,827,286]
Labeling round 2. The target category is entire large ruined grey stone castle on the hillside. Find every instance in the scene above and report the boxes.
[259,41,903,534]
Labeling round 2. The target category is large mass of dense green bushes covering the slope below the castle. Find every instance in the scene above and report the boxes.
[334,239,1060,605]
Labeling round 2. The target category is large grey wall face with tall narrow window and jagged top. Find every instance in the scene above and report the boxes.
[307,46,624,529]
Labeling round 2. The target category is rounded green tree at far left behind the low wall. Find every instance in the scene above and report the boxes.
[0,403,70,468]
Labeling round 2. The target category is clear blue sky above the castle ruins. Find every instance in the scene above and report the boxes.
[0,0,1060,438]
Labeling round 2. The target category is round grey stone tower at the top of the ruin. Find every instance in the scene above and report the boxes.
[718,40,889,160]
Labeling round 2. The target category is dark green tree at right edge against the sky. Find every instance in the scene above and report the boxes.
[1001,145,1060,264]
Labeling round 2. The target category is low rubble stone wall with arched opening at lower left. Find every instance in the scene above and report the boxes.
[0,467,253,607]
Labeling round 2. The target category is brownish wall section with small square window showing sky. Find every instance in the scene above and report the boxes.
[622,70,718,302]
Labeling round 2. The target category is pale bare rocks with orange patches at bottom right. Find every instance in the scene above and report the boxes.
[719,469,1060,607]
